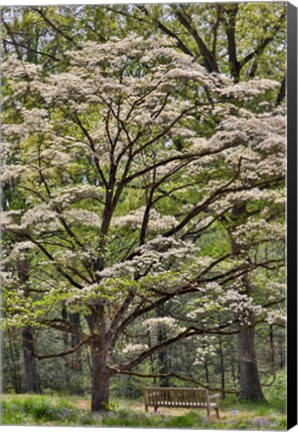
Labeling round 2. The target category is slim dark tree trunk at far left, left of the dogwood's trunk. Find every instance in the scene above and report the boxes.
[22,326,41,394]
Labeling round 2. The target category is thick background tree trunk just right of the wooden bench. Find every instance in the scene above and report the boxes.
[238,325,265,401]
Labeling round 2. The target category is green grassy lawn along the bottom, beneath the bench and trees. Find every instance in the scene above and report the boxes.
[1,395,286,430]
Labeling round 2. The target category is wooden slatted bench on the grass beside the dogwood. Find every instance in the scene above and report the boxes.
[143,387,219,418]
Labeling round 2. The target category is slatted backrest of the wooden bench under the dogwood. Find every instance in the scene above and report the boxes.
[144,387,209,408]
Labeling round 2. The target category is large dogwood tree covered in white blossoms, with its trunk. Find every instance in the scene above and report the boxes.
[2,35,285,411]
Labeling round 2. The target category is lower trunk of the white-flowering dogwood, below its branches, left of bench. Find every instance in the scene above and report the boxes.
[91,343,110,412]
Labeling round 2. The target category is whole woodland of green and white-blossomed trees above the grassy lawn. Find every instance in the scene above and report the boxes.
[1,2,286,418]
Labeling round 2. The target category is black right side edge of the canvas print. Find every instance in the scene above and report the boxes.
[287,3,297,429]
